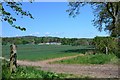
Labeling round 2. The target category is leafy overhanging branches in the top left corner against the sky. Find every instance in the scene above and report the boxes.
[0,1,34,31]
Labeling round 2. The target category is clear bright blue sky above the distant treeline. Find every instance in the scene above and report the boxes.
[2,2,108,38]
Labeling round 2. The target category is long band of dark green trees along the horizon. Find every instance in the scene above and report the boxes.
[2,36,93,46]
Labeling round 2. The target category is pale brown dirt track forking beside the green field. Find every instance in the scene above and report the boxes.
[17,55,120,78]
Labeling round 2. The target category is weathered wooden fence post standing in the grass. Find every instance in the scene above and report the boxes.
[10,44,17,73]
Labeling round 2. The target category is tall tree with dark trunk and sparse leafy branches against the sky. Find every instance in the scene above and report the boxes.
[67,0,120,37]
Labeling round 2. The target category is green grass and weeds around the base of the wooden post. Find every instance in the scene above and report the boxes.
[2,61,65,80]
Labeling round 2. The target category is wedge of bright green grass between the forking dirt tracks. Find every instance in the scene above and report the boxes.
[55,53,118,64]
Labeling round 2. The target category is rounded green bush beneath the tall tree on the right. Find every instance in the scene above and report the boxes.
[94,37,118,53]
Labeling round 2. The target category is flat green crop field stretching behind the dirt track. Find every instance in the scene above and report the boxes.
[2,45,93,61]
